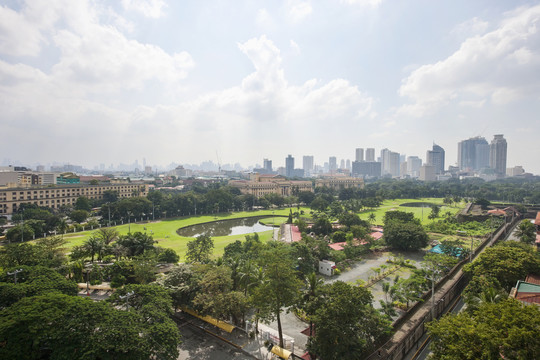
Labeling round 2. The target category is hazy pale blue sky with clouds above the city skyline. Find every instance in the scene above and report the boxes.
[0,0,540,174]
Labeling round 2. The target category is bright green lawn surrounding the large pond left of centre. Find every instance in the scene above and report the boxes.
[60,208,309,259]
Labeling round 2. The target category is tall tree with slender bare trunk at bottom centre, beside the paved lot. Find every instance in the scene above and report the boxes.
[253,244,300,347]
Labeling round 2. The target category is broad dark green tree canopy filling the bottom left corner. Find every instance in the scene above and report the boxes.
[0,294,180,360]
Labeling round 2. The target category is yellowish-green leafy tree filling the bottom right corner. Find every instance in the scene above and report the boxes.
[428,299,540,360]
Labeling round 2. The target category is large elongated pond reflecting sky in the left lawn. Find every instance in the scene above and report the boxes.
[176,215,273,237]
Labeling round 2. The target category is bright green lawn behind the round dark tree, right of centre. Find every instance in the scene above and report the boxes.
[358,198,463,225]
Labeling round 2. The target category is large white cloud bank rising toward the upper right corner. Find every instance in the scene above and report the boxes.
[398,6,540,116]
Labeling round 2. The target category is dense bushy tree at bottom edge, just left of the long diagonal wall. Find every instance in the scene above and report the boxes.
[308,281,391,360]
